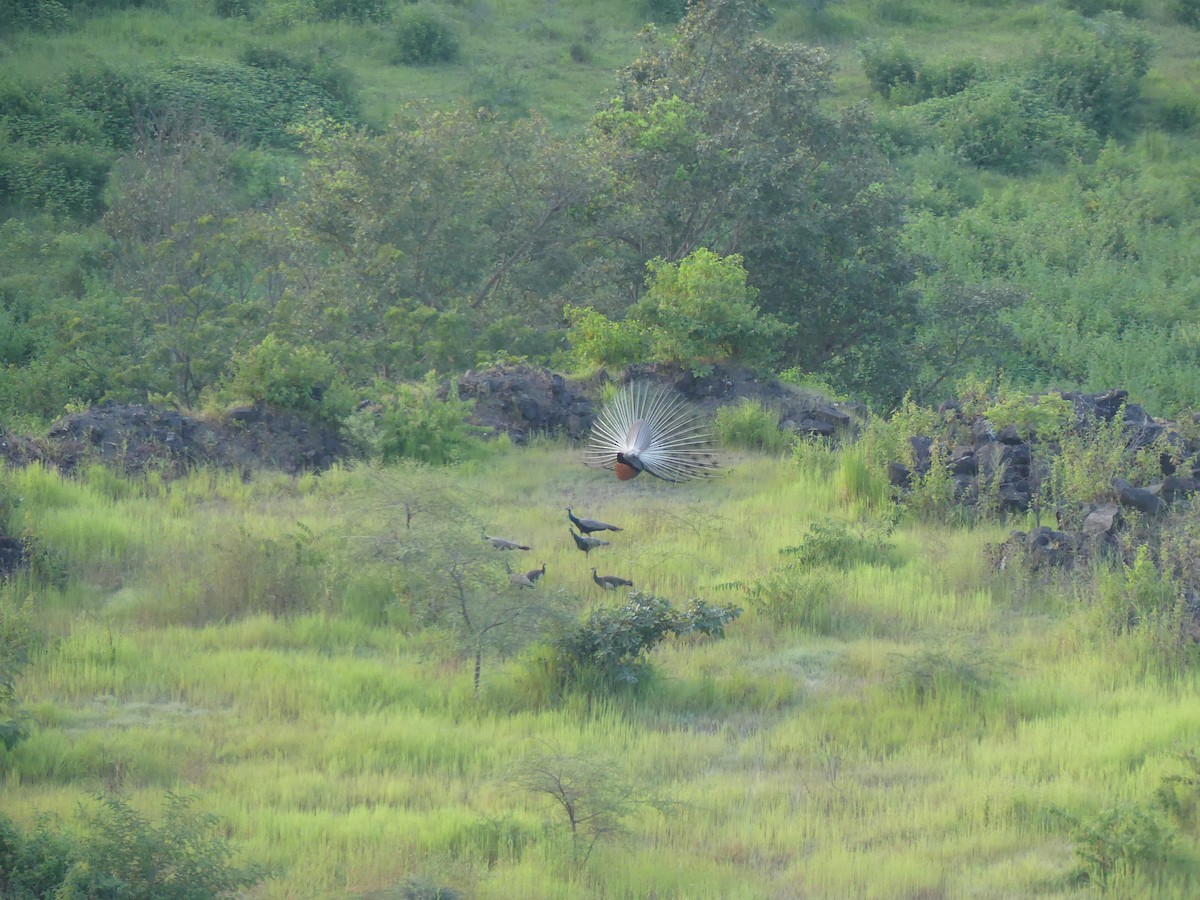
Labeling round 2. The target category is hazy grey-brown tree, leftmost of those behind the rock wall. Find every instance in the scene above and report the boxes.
[95,122,281,404]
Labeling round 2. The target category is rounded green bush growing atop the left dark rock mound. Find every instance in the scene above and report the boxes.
[216,335,354,422]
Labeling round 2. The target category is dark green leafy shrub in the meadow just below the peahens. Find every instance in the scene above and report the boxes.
[552,590,742,690]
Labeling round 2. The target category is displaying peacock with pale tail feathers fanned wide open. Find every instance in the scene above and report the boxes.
[583,383,718,481]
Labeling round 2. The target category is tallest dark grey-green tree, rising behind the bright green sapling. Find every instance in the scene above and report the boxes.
[592,0,916,395]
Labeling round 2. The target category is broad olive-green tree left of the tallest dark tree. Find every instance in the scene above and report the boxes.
[272,106,587,380]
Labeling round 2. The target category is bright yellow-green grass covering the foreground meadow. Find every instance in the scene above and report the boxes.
[0,442,1200,898]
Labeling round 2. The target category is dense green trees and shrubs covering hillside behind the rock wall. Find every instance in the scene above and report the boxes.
[0,0,1200,426]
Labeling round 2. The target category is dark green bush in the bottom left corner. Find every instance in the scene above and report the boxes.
[0,794,264,900]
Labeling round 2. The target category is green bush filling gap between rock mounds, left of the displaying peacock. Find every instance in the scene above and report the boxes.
[346,372,476,466]
